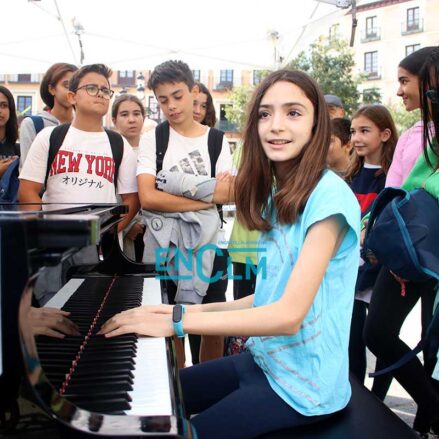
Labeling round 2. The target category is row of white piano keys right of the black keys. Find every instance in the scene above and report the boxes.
[125,278,172,416]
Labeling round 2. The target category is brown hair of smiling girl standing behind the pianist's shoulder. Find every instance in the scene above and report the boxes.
[345,104,398,181]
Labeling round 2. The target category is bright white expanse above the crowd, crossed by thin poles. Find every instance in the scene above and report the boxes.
[0,0,339,73]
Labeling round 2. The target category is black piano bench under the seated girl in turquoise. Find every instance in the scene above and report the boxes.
[260,377,419,439]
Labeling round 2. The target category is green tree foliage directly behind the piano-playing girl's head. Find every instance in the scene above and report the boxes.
[288,37,362,115]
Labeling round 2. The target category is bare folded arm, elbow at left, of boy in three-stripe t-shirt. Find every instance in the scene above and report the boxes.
[137,174,212,212]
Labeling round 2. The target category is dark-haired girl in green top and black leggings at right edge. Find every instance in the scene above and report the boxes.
[365,48,439,437]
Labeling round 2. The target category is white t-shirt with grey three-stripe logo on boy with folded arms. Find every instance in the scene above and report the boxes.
[137,127,232,177]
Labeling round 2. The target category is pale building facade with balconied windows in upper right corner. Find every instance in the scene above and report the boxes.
[324,0,439,105]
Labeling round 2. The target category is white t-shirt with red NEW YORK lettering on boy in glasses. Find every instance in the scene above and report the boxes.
[20,126,137,209]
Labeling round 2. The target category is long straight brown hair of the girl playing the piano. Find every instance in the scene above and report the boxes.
[235,70,331,231]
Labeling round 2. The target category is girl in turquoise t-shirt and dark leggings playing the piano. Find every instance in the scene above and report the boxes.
[100,70,360,439]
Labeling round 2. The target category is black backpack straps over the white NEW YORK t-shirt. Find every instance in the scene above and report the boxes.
[44,123,123,189]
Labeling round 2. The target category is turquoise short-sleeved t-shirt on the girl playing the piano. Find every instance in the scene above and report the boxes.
[247,171,360,416]
